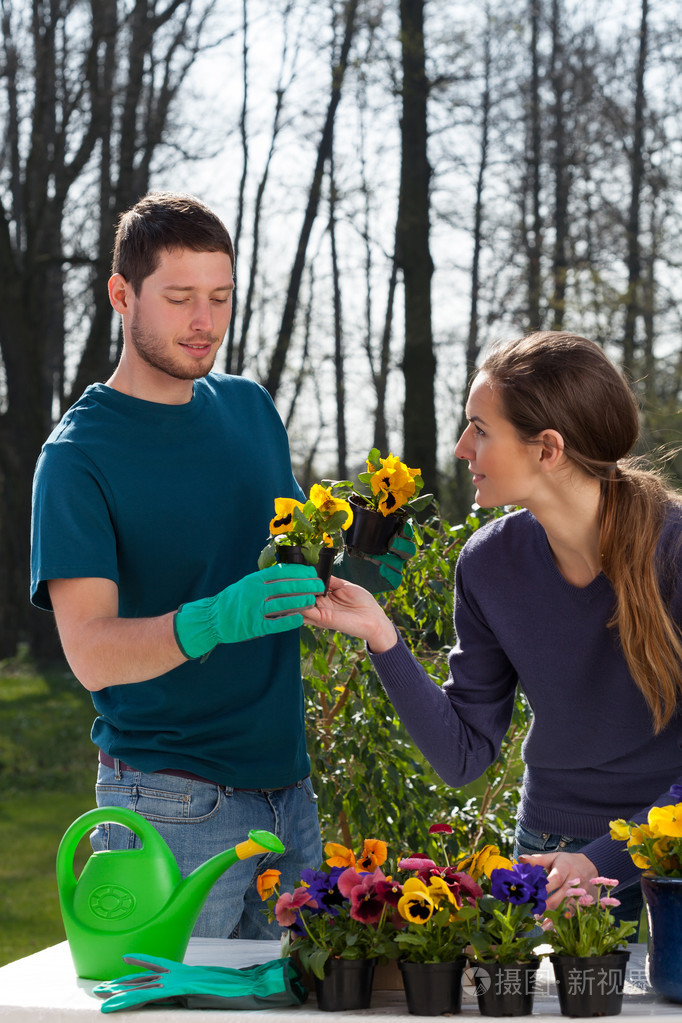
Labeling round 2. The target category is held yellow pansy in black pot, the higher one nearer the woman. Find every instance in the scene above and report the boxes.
[324,448,434,555]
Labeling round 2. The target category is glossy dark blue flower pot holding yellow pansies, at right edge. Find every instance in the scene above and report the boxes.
[641,874,682,1002]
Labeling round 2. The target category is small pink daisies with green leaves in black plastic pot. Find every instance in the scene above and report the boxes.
[543,877,638,1016]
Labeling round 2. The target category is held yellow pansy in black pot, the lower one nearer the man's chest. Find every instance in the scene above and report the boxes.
[258,483,353,584]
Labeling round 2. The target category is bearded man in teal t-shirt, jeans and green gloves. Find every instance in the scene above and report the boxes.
[32,192,413,938]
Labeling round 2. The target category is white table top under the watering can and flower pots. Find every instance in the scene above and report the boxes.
[0,938,682,1023]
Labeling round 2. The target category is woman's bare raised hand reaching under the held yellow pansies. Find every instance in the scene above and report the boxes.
[302,576,398,654]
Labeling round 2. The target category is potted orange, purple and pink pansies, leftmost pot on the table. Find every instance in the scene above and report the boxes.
[258,839,400,1012]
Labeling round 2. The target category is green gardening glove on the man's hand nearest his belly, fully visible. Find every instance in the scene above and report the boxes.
[173,565,324,658]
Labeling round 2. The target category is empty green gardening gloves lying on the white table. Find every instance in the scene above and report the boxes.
[93,954,308,1013]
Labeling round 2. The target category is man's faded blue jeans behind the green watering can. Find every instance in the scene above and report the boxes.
[90,764,322,939]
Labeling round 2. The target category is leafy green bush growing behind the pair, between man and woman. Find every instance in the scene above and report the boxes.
[302,510,530,855]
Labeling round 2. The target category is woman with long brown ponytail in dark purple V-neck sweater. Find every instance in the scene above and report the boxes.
[304,332,682,919]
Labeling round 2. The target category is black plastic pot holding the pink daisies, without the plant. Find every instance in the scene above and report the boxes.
[549,950,630,1016]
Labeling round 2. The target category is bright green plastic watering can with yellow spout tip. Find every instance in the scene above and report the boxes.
[57,806,284,980]
